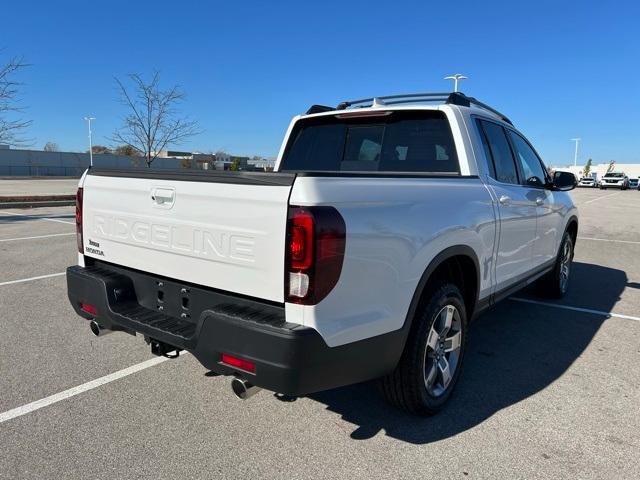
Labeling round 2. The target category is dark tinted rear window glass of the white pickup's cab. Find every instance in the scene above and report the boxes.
[280,110,460,174]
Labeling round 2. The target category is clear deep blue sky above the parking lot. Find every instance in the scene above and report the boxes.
[0,0,640,165]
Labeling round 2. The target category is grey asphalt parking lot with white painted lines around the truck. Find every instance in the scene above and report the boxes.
[0,189,640,479]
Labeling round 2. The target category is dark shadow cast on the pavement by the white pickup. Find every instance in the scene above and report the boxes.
[309,263,627,444]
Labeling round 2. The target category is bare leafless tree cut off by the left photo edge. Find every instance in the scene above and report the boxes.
[0,53,31,146]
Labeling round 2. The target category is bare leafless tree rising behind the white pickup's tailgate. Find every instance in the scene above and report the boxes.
[111,72,201,167]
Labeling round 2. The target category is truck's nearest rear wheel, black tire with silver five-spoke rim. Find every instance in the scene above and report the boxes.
[379,282,467,415]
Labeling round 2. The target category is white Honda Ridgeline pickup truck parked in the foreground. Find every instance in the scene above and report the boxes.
[67,93,578,414]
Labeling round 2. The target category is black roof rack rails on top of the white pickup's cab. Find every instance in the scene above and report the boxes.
[307,92,513,125]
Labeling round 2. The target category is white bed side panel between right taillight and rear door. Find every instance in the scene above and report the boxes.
[286,176,496,346]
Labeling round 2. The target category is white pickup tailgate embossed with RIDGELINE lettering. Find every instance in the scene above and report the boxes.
[83,169,295,302]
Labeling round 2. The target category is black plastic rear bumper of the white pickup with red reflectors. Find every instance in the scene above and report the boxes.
[67,262,404,395]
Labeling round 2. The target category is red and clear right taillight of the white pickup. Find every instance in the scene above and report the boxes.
[285,206,346,305]
